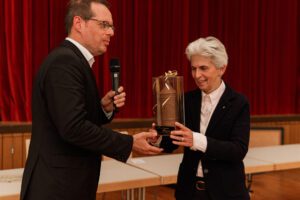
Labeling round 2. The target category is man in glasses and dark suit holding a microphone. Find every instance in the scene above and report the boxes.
[21,0,161,200]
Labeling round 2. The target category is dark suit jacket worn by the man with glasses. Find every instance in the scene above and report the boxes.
[21,40,133,200]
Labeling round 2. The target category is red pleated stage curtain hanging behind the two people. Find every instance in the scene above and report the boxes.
[0,0,300,121]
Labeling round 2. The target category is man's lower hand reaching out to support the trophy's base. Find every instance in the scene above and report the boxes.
[132,131,163,155]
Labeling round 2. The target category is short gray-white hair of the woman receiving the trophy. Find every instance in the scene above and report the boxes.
[185,36,228,68]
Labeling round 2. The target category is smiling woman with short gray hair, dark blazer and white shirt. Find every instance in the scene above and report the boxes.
[161,37,250,200]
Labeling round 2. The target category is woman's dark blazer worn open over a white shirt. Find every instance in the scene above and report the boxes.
[161,85,250,200]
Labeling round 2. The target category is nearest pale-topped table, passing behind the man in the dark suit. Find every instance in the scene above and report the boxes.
[0,160,160,200]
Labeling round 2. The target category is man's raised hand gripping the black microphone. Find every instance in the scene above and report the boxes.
[101,86,126,113]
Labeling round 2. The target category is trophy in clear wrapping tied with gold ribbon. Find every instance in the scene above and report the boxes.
[152,71,185,136]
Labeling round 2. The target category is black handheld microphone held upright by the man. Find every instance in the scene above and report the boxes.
[109,58,121,112]
